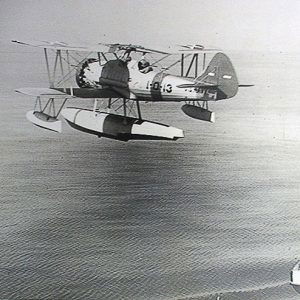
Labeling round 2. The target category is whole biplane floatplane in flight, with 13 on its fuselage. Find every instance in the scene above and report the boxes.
[12,40,248,141]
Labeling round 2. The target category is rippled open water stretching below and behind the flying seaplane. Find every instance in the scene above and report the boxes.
[0,47,300,300]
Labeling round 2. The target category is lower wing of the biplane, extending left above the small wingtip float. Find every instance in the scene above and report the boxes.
[16,88,121,98]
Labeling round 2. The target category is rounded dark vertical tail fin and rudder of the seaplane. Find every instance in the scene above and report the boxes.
[196,52,239,100]
